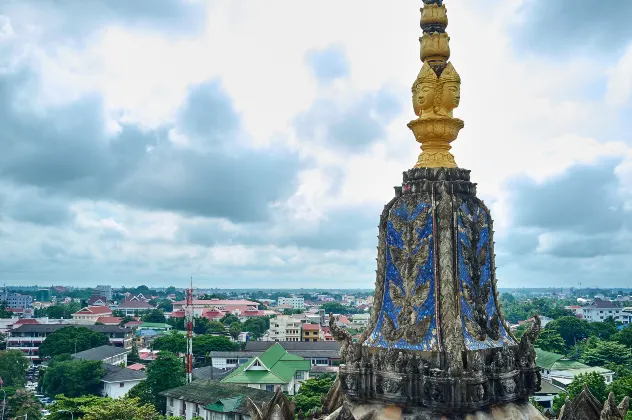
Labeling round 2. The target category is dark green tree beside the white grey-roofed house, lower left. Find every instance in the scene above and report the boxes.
[42,360,105,397]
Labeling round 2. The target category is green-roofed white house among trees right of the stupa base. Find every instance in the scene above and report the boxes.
[535,348,614,388]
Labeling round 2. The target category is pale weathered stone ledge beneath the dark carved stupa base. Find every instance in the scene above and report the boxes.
[325,401,546,420]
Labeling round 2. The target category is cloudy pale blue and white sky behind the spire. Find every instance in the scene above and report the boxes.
[0,0,632,288]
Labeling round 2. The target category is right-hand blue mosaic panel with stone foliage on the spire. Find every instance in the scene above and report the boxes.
[457,203,517,350]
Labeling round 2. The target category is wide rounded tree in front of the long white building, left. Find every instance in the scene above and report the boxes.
[38,327,109,357]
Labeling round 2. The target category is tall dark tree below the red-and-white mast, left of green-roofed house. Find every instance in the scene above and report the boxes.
[145,351,185,411]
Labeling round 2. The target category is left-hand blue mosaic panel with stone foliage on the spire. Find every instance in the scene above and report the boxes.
[365,200,439,351]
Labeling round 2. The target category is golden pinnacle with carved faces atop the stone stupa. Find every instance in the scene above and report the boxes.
[408,0,464,168]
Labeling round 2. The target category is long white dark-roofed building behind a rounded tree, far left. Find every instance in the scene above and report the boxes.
[7,324,133,362]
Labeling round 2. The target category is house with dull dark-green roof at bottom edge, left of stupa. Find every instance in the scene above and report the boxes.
[160,379,274,420]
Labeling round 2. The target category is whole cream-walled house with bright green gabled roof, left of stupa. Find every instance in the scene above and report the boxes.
[222,343,311,395]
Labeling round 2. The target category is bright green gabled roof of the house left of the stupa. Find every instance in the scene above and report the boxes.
[222,343,311,384]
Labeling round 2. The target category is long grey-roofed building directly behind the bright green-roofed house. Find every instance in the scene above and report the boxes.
[209,341,340,369]
